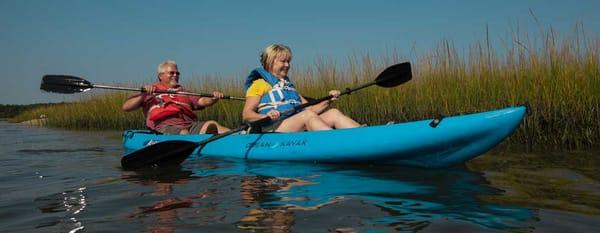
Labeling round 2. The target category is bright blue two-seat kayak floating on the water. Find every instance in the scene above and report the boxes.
[123,106,526,167]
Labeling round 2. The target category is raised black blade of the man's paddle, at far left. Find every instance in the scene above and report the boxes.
[40,75,94,94]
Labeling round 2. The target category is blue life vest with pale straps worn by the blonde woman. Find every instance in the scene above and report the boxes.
[244,67,302,119]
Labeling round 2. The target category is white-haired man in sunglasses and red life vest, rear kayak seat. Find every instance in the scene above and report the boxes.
[123,60,229,134]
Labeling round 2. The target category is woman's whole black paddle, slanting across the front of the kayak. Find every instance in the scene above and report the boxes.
[121,62,412,170]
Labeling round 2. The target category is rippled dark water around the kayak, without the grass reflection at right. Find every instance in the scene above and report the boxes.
[0,122,600,232]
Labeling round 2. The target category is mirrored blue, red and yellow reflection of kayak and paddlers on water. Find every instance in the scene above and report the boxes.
[122,158,534,232]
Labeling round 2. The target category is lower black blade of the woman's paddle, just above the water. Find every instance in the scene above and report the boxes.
[121,140,200,170]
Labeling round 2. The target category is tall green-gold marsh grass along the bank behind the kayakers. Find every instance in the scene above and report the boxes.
[15,25,600,149]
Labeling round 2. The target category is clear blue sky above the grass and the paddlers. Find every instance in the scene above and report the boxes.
[0,0,600,104]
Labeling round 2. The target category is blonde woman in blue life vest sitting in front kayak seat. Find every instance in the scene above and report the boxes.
[242,44,360,132]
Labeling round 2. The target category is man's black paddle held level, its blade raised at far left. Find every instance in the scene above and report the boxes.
[40,74,244,100]
